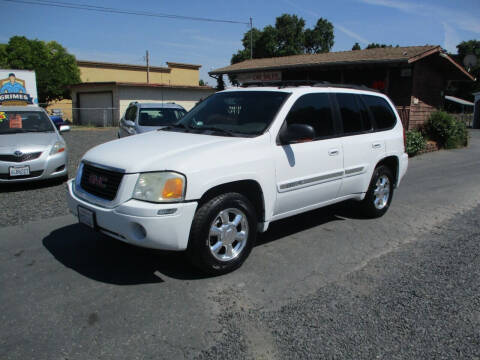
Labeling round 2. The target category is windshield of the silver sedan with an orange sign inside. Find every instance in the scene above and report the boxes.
[0,111,54,134]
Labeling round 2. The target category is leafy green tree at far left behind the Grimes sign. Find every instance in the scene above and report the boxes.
[0,36,80,103]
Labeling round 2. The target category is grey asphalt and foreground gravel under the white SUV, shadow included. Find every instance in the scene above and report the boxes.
[0,131,480,359]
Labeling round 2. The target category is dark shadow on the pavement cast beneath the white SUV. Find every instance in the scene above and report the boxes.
[43,202,368,285]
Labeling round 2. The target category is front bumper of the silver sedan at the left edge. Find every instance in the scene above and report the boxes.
[0,151,68,183]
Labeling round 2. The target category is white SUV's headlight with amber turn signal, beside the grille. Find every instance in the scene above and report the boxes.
[132,172,186,203]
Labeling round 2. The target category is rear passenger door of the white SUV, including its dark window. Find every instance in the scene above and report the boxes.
[335,93,385,196]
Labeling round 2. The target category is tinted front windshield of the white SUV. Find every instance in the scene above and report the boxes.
[173,91,289,136]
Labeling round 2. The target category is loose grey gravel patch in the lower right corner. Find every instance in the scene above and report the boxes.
[199,207,480,359]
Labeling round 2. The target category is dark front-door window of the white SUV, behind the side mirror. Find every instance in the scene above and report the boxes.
[287,94,335,138]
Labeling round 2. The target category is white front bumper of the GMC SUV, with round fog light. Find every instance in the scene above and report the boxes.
[68,179,197,251]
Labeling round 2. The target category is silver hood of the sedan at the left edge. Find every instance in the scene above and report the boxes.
[0,131,60,154]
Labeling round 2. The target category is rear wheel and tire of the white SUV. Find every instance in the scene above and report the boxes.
[360,165,394,218]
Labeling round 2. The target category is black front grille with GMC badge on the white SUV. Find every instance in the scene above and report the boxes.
[80,163,123,200]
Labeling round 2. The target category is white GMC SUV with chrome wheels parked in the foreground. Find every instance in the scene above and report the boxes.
[68,85,408,274]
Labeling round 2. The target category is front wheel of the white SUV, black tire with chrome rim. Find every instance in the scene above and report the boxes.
[187,193,257,275]
